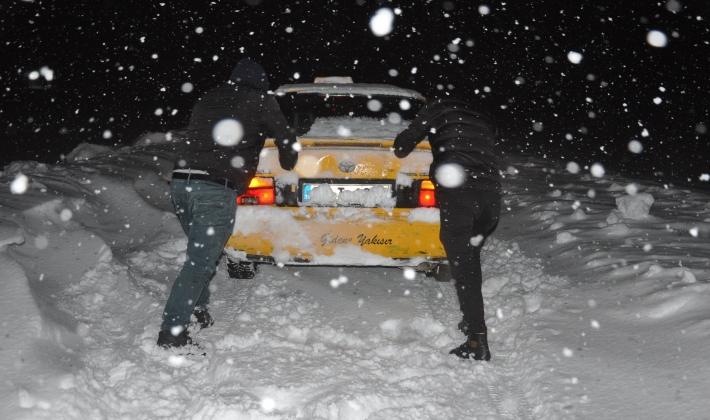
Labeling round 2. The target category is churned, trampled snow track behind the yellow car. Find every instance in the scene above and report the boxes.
[37,235,560,419]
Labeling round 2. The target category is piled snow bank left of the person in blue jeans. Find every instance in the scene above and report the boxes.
[0,140,182,418]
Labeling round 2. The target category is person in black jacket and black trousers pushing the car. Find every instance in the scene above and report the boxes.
[394,96,501,360]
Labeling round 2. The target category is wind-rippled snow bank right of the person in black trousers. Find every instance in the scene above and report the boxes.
[492,156,710,418]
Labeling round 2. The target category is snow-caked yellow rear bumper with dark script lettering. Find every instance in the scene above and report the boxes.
[225,206,446,267]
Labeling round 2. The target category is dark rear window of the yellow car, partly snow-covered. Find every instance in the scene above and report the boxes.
[276,93,423,137]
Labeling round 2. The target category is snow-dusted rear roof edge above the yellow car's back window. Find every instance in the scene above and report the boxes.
[274,83,426,101]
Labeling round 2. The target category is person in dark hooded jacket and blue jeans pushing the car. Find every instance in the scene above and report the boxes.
[158,58,299,348]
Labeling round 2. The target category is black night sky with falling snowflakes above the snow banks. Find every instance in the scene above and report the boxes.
[0,0,710,188]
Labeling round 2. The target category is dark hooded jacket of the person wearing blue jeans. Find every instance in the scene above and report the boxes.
[174,58,298,195]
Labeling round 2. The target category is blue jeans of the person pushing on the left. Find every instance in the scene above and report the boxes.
[160,179,237,330]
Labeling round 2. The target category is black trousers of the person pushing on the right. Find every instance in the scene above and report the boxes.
[435,187,501,334]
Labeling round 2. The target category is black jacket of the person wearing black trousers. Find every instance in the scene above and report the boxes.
[394,98,500,190]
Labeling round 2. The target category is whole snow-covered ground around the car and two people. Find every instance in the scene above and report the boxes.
[0,139,710,420]
